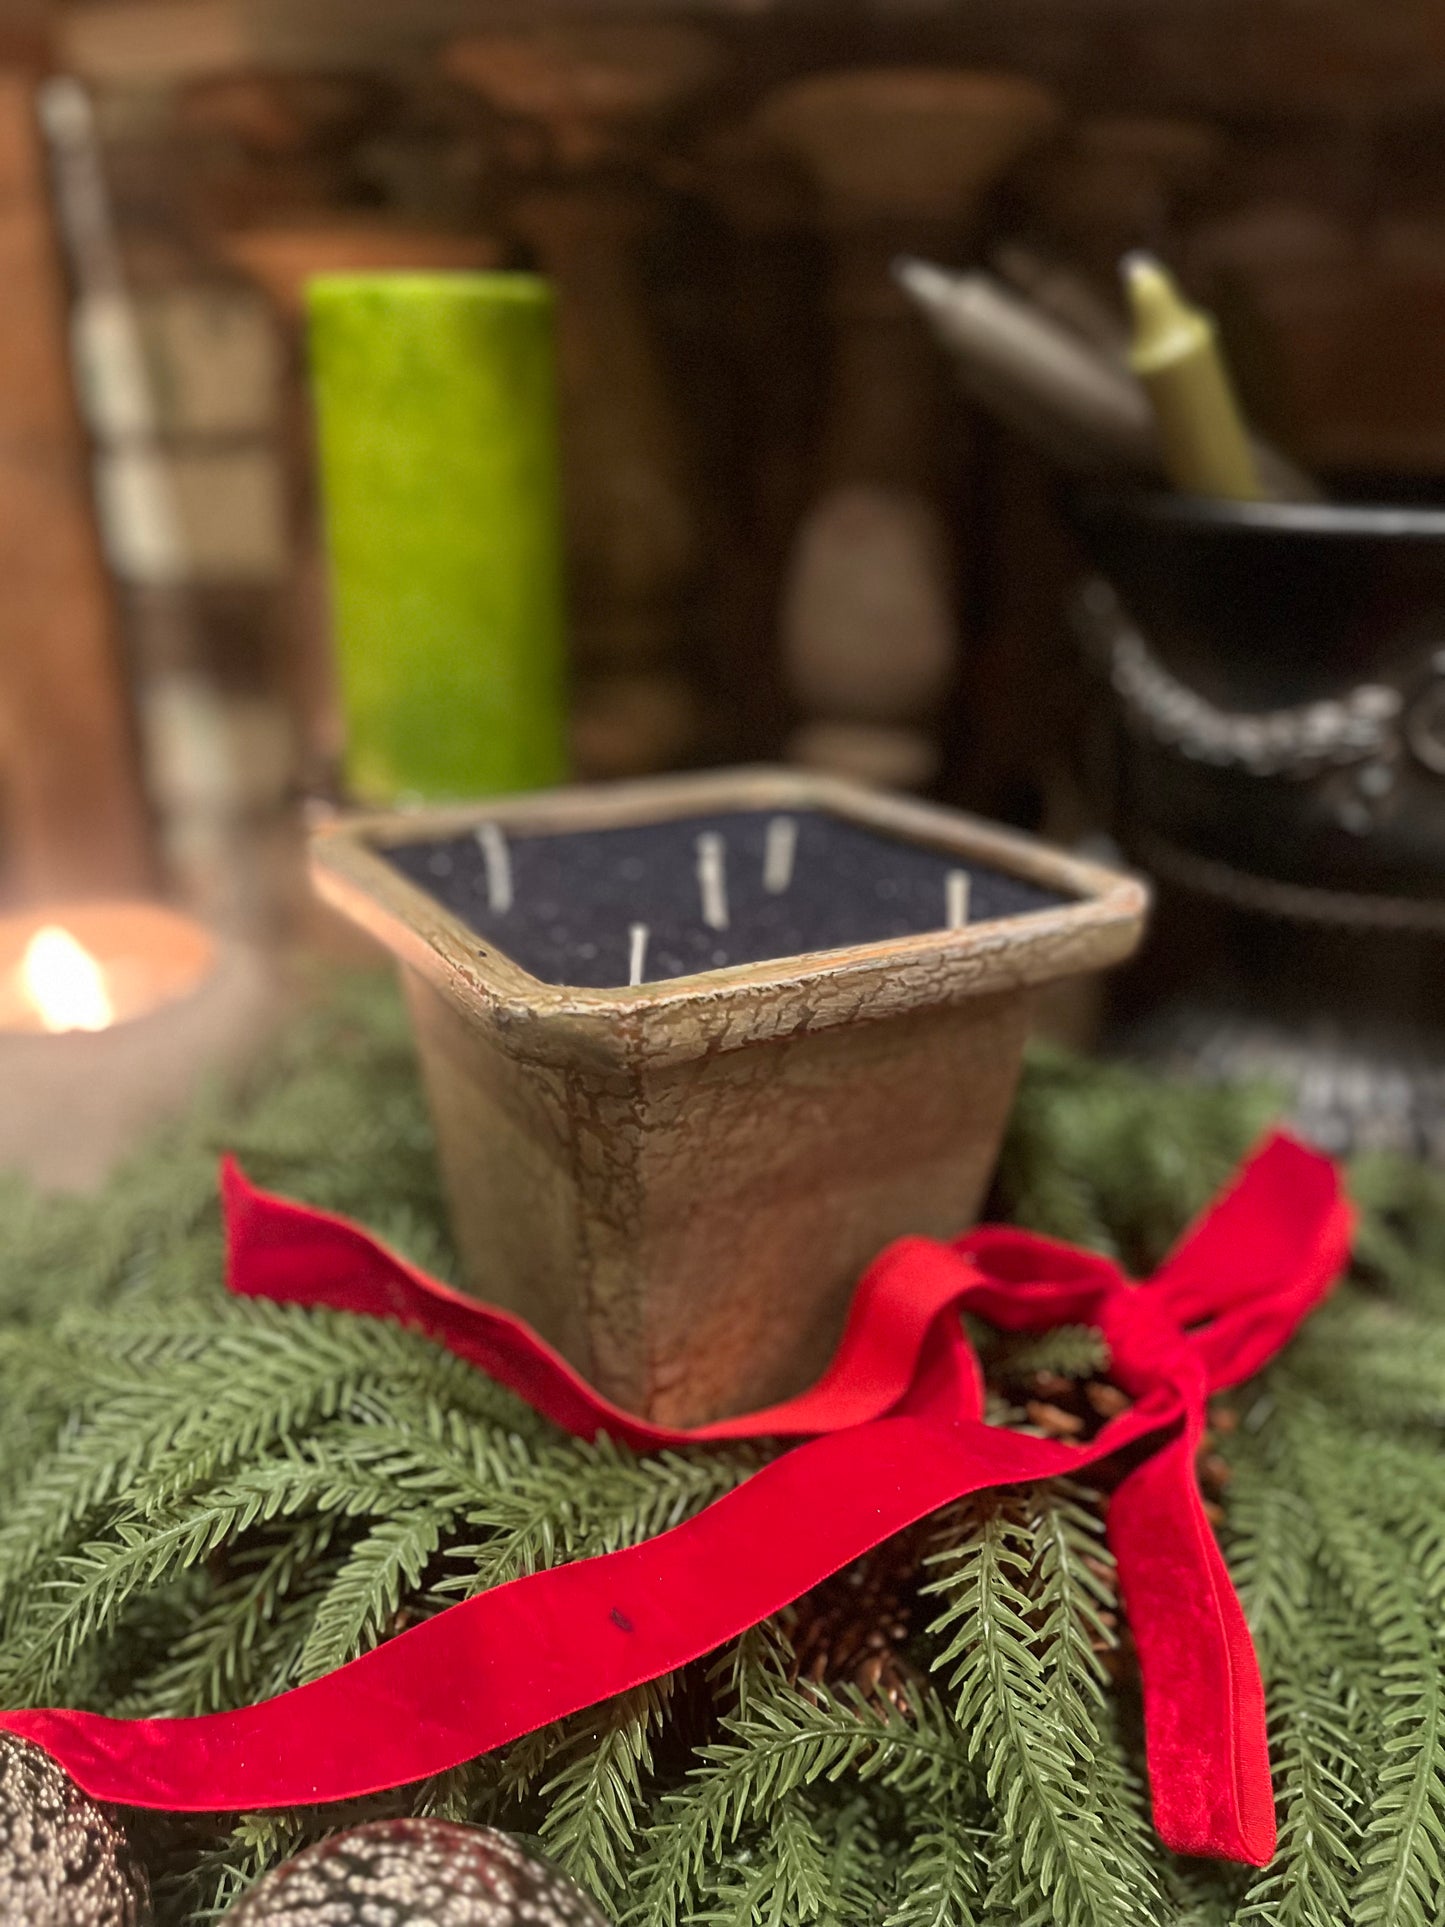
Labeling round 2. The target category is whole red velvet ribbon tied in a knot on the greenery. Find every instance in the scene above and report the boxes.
[0,1137,1353,1865]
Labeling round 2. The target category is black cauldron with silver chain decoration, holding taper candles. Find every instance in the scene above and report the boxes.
[1071,493,1445,1160]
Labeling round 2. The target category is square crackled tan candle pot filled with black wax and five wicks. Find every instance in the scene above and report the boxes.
[312,769,1144,1424]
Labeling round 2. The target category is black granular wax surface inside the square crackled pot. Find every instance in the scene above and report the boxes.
[385,809,1064,990]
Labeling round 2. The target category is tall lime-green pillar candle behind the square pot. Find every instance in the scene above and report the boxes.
[306,274,566,804]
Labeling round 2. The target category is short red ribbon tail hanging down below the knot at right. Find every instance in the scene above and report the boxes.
[1108,1426,1275,1867]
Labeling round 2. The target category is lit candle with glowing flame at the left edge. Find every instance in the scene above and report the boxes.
[0,902,272,1189]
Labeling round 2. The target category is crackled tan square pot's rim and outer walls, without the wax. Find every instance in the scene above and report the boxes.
[314,771,1144,1424]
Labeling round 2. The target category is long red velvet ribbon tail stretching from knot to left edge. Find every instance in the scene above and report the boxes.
[0,1418,1131,1813]
